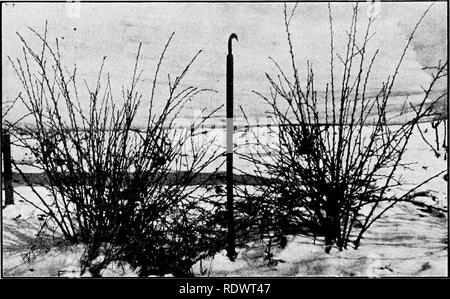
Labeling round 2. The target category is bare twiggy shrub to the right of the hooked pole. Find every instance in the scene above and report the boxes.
[240,4,448,252]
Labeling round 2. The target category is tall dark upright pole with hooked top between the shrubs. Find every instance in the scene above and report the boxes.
[226,33,238,261]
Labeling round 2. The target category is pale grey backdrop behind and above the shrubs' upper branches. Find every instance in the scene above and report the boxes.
[2,2,448,126]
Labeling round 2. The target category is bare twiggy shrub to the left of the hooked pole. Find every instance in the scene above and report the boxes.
[10,25,225,276]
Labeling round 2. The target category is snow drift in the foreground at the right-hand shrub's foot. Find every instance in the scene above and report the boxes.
[194,200,448,277]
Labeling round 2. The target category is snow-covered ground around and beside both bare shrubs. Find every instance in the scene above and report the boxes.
[2,124,448,277]
